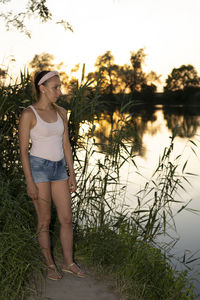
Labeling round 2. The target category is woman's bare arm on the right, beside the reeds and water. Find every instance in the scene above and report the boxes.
[62,108,77,192]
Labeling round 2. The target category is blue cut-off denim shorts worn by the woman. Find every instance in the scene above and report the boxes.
[29,155,68,183]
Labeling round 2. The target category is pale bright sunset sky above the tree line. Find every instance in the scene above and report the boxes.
[0,0,200,90]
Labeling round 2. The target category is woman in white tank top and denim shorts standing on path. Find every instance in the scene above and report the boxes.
[19,71,86,280]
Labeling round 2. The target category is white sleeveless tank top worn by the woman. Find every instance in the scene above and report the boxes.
[29,105,64,161]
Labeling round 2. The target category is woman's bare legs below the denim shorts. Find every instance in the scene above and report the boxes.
[31,180,84,274]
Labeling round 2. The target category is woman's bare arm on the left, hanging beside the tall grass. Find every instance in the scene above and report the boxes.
[19,109,38,200]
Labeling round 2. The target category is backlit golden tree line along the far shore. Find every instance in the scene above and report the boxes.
[0,48,200,103]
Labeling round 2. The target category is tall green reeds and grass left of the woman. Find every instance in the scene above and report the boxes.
[0,74,43,300]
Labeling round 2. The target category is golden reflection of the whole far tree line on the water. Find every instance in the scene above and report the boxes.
[88,106,200,157]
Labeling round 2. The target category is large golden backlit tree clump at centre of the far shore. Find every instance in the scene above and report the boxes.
[88,49,159,95]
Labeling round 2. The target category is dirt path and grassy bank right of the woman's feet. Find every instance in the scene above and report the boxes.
[28,231,194,300]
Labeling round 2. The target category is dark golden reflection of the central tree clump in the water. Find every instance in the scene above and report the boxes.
[90,108,157,156]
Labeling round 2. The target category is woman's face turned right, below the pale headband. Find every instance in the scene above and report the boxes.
[42,76,62,102]
